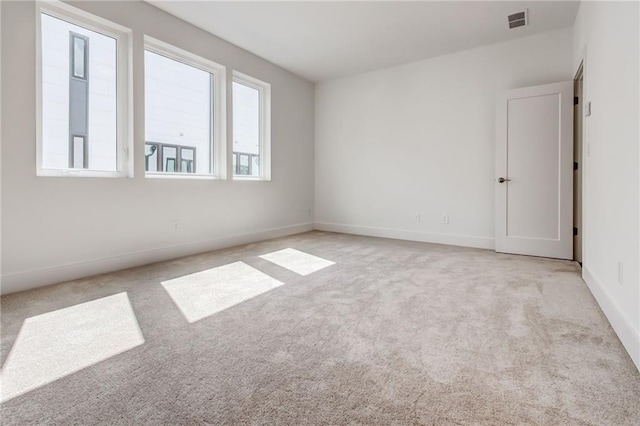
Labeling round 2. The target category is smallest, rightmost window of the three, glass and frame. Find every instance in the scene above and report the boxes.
[233,72,271,180]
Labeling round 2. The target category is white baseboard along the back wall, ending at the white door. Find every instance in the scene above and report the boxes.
[315,222,495,250]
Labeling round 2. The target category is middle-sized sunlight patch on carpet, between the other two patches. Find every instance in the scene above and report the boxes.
[162,262,283,323]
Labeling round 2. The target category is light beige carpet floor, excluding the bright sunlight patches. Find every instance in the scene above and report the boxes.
[1,232,640,425]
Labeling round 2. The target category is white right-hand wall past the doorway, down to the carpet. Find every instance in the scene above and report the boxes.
[573,2,640,369]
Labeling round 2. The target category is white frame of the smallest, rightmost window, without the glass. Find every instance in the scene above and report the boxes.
[231,70,271,181]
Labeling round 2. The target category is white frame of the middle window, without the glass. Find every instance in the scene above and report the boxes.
[143,35,227,179]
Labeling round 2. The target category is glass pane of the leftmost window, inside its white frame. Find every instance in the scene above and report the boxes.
[41,13,118,171]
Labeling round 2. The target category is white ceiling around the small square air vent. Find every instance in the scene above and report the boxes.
[146,0,578,81]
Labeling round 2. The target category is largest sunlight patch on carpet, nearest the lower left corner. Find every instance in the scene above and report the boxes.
[0,293,144,402]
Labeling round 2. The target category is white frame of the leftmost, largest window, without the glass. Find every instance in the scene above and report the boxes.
[36,0,133,177]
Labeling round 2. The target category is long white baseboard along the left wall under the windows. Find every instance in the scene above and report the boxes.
[0,222,314,294]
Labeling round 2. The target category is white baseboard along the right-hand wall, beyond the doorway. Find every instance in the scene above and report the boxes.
[582,265,640,371]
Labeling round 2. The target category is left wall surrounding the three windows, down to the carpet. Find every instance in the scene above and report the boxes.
[0,1,314,293]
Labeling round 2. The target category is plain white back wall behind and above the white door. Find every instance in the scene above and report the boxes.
[315,29,572,248]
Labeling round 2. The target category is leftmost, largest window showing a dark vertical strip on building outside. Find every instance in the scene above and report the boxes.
[37,3,132,176]
